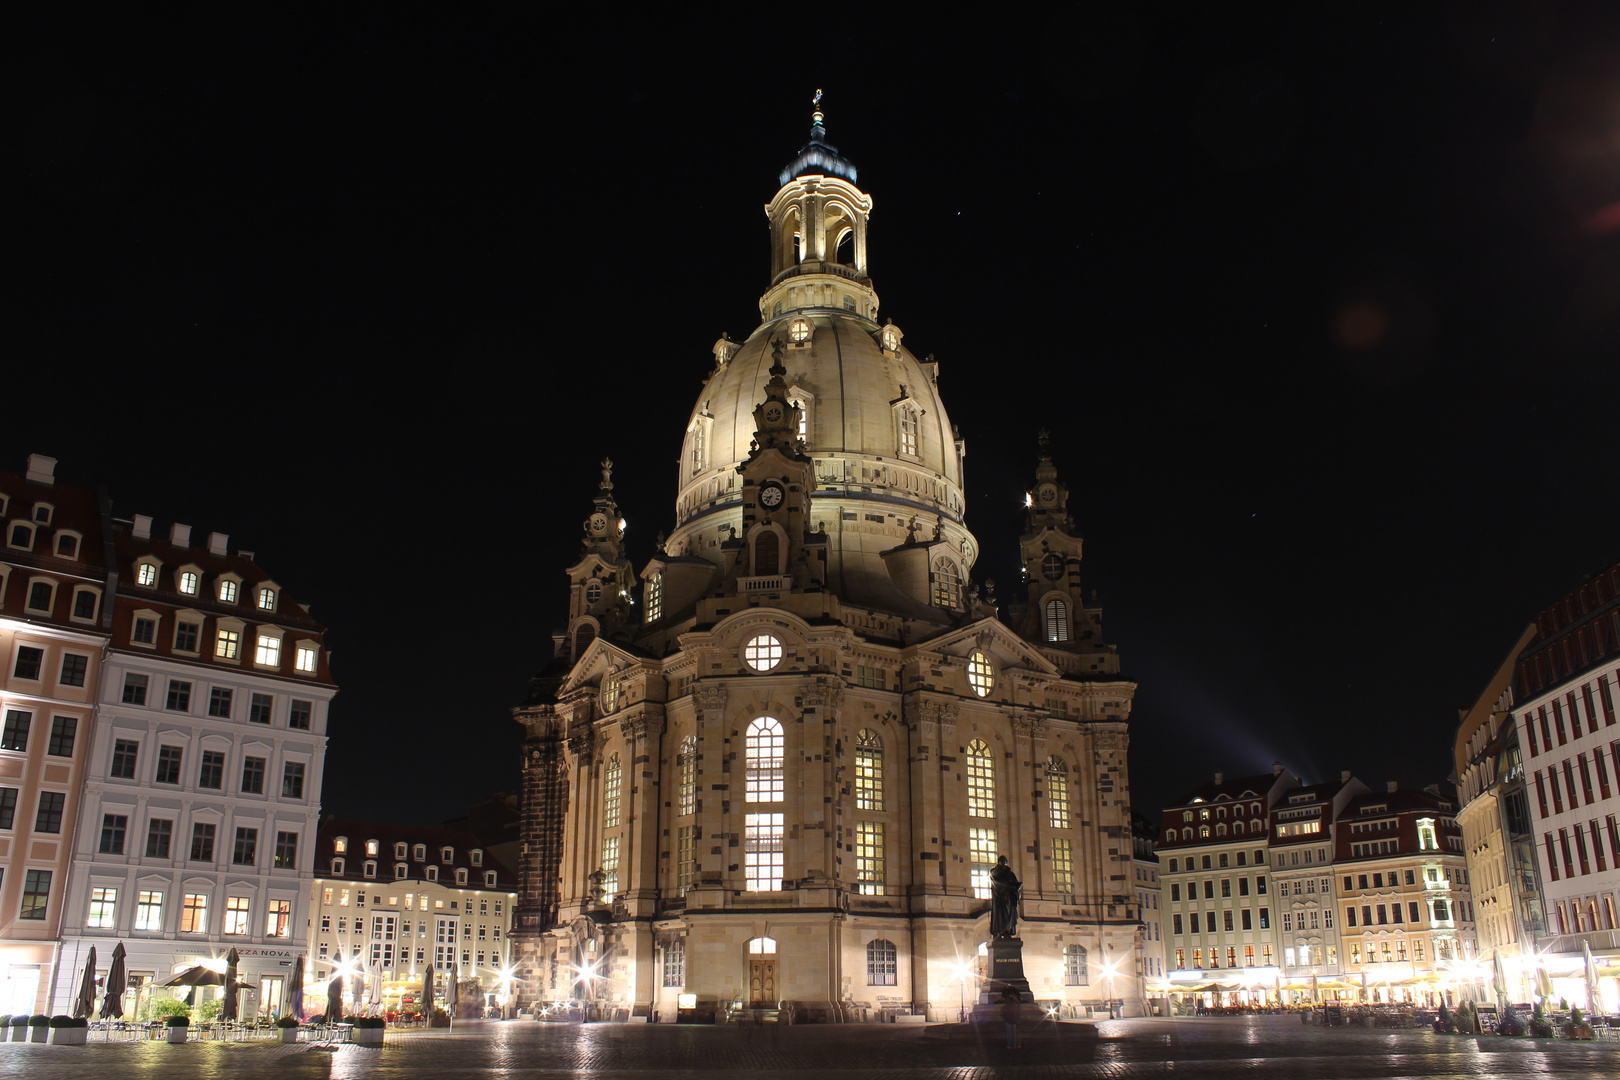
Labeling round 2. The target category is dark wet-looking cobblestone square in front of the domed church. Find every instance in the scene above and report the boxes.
[0,1017,1620,1080]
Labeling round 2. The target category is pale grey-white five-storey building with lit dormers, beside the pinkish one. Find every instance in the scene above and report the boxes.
[52,515,337,1014]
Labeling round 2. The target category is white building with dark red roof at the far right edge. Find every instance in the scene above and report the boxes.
[1511,565,1620,1007]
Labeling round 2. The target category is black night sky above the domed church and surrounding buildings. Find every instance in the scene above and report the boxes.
[0,3,1620,824]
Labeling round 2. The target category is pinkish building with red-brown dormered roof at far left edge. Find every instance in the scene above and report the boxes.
[0,453,113,1014]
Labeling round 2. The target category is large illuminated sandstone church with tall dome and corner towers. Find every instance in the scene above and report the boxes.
[514,112,1142,1020]
